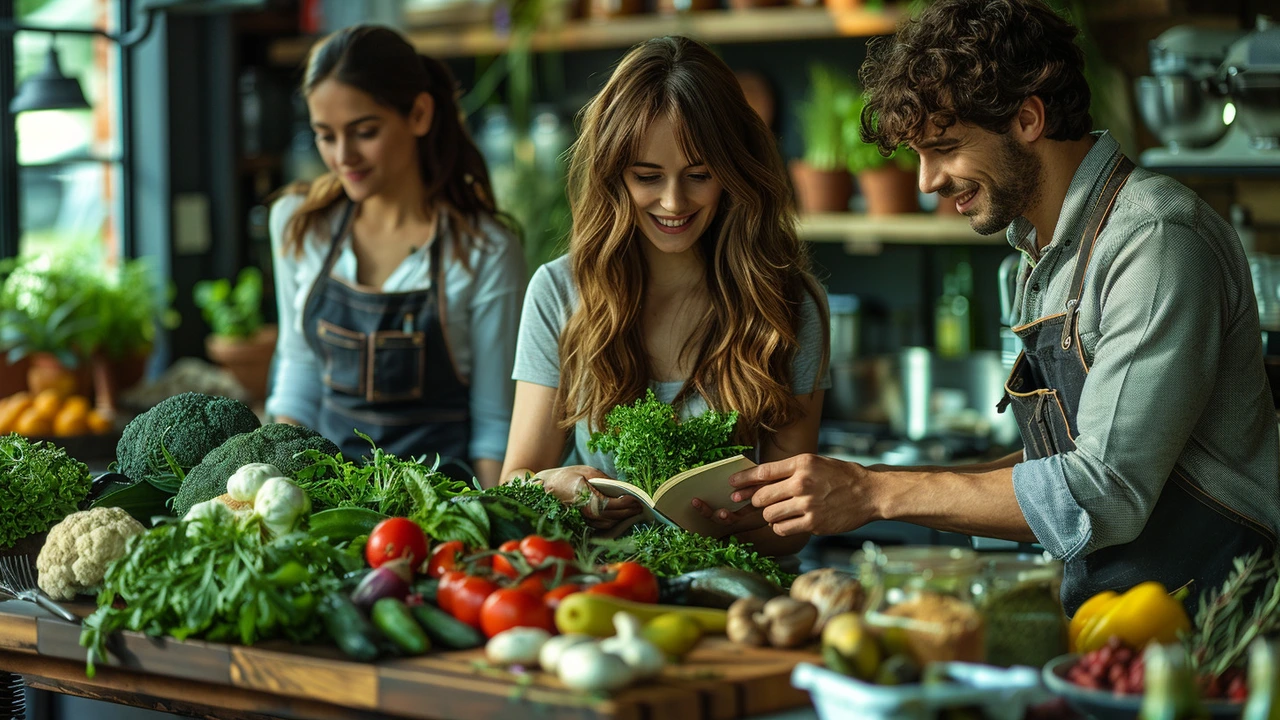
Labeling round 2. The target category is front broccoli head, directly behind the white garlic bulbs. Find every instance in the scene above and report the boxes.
[173,423,339,518]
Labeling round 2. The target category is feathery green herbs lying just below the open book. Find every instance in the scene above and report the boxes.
[596,525,796,588]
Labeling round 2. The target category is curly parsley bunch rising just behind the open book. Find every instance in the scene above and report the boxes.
[586,389,746,495]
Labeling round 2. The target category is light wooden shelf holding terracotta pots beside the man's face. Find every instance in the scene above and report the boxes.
[800,213,1007,251]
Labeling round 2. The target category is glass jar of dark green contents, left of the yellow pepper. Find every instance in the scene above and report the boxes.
[973,552,1066,667]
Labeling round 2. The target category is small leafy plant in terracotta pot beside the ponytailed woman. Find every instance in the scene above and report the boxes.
[193,268,276,400]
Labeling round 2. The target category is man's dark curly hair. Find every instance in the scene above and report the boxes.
[859,0,1092,155]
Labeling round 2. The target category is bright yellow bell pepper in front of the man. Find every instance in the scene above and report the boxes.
[1068,582,1192,652]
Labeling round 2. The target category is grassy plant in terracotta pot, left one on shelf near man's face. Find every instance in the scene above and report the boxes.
[791,64,854,213]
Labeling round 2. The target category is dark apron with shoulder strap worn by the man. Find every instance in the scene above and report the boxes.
[1000,154,1275,616]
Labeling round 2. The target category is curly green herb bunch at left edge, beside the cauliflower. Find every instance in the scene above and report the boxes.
[0,434,92,547]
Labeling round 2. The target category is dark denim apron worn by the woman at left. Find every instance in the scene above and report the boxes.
[302,204,471,478]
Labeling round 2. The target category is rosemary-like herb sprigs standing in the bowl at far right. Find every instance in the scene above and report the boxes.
[1183,548,1280,676]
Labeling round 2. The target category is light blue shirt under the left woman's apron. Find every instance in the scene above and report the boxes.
[266,195,527,462]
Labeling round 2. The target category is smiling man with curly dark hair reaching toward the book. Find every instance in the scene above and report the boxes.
[732,0,1280,615]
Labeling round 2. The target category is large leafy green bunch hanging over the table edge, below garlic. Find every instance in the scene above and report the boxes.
[81,515,360,678]
